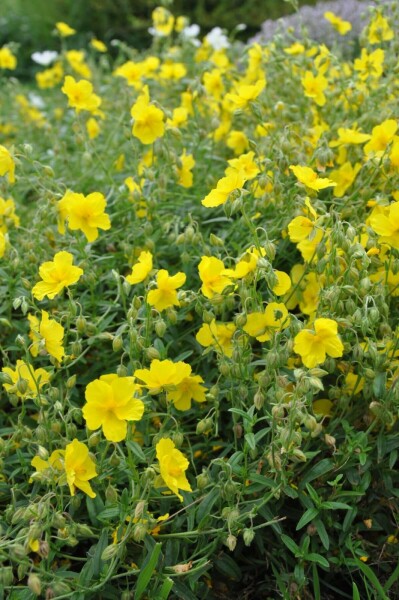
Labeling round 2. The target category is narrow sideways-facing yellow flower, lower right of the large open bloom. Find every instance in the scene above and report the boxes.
[156,438,192,502]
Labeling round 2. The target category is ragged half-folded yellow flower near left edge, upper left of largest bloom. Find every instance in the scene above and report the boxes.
[28,310,65,362]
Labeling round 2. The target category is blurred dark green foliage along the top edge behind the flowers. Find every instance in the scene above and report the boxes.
[0,0,316,76]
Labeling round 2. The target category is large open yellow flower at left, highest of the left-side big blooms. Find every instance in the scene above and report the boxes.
[58,190,111,242]
